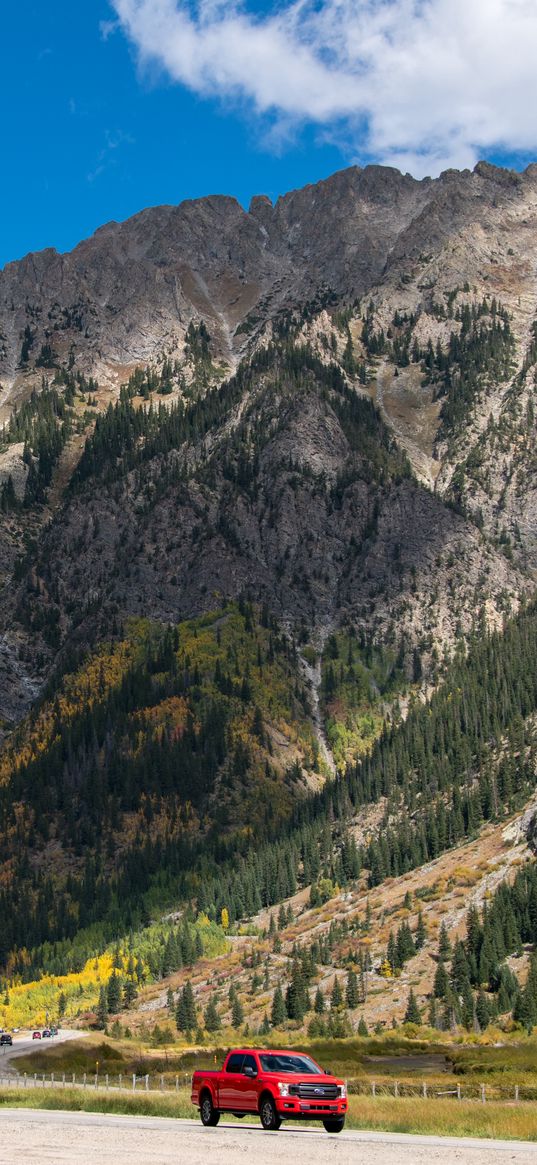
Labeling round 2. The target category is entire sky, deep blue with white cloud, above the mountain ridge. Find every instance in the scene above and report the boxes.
[0,0,537,264]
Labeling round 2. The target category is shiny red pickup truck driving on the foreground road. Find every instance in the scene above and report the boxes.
[192,1047,347,1132]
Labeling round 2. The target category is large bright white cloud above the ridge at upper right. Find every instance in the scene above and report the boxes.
[113,0,537,176]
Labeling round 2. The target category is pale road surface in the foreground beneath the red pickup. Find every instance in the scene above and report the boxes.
[0,1109,537,1165]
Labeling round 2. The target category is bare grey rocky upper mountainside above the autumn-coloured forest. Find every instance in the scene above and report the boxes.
[0,163,537,720]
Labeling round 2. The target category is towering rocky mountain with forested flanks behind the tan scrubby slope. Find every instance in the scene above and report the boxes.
[0,163,537,1029]
